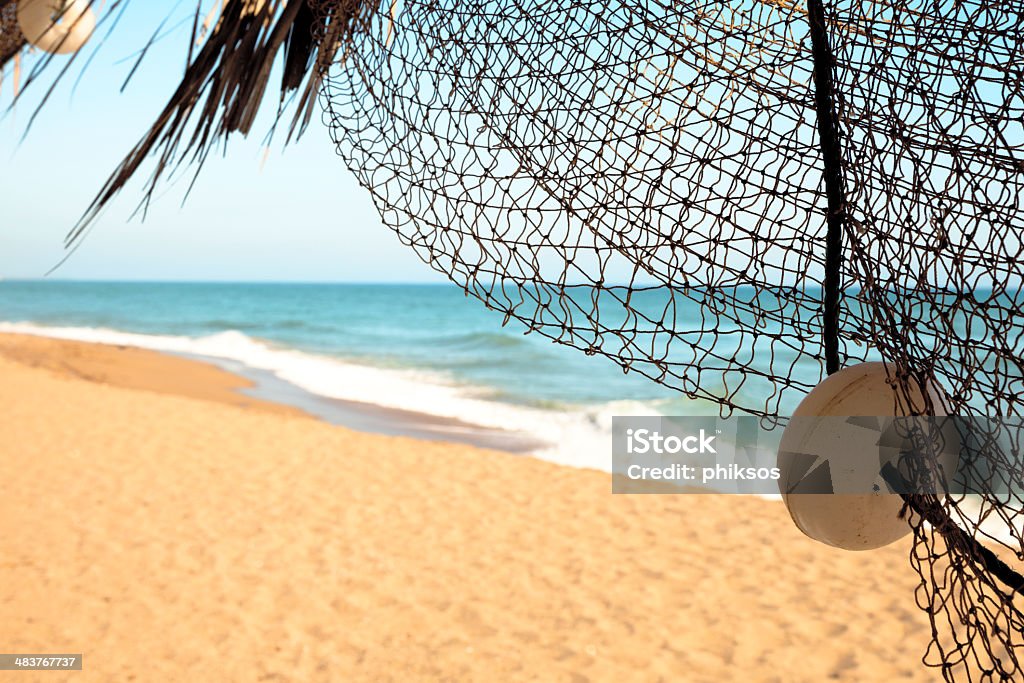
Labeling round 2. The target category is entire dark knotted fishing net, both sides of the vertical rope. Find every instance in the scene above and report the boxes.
[321,0,1024,681]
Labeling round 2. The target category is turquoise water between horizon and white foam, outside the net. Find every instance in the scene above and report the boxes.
[0,282,704,407]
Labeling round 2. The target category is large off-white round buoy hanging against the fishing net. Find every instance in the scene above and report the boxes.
[778,362,958,550]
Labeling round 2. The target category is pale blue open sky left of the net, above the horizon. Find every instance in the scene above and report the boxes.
[0,2,443,283]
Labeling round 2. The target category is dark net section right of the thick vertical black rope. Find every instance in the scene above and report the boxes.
[830,0,1024,680]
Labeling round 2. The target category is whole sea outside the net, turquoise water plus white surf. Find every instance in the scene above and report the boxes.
[0,281,820,471]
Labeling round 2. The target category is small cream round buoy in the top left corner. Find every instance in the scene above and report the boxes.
[17,0,96,54]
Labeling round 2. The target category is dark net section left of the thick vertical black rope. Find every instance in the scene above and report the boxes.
[327,1,856,415]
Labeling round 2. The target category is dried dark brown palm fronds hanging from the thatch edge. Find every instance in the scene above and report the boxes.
[0,0,379,240]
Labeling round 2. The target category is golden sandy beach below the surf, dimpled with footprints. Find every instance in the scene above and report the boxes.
[0,336,938,682]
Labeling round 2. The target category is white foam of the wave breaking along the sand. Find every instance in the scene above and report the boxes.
[0,323,658,471]
